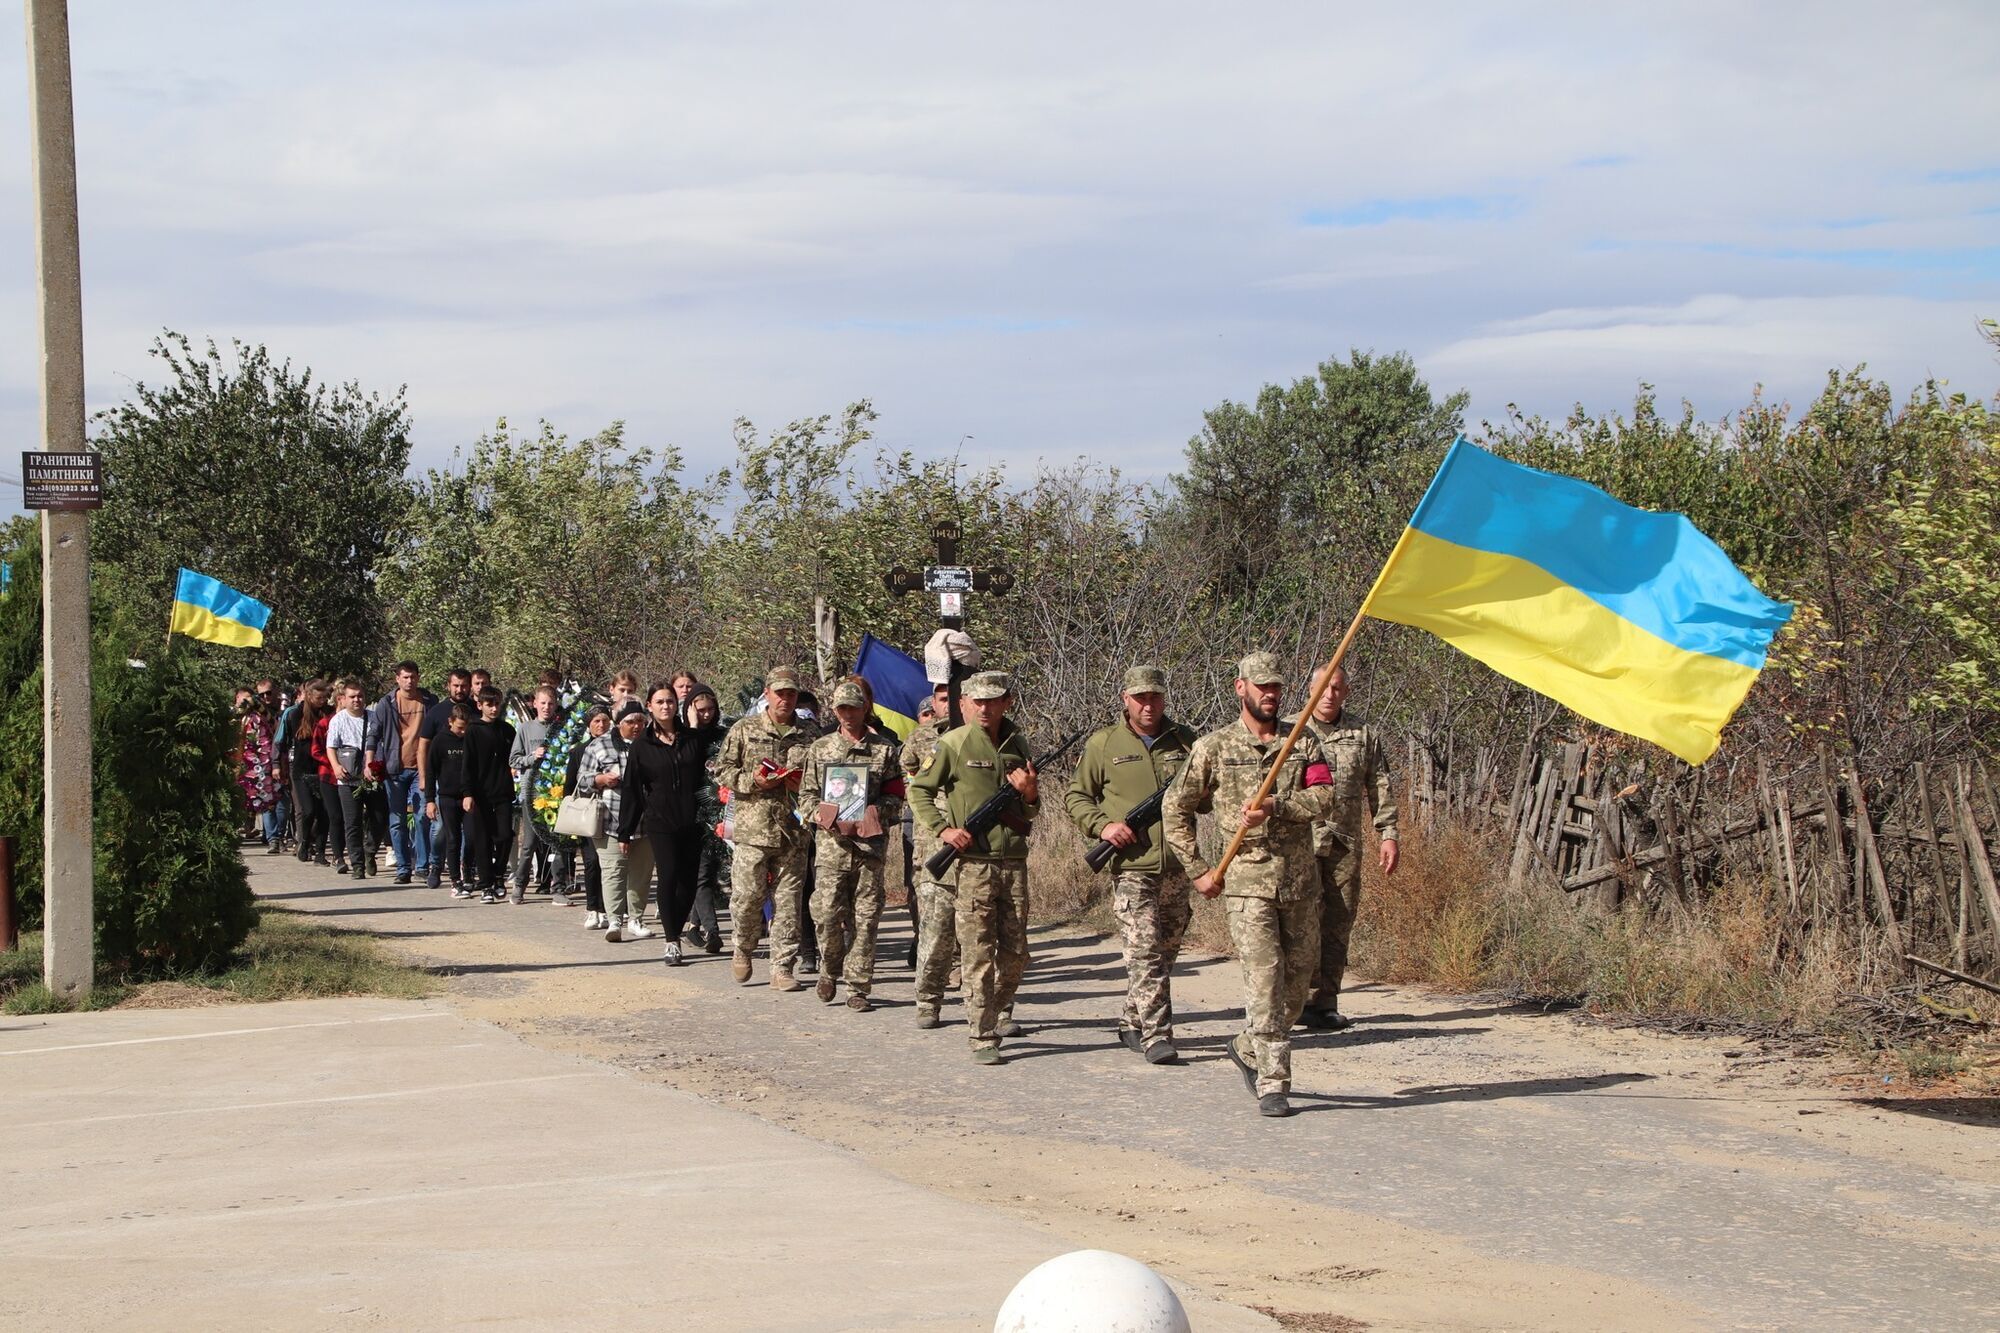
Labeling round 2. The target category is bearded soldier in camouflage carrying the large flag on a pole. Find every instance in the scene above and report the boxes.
[1162,652,1334,1115]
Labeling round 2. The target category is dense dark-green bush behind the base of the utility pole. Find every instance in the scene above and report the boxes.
[0,536,256,975]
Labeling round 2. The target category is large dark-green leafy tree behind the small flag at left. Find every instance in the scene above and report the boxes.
[92,332,410,677]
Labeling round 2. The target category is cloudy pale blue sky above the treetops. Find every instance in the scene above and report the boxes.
[0,0,2000,494]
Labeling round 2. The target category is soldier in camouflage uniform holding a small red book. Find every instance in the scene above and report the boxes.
[716,667,812,991]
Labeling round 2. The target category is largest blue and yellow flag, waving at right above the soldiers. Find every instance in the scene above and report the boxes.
[1362,438,1792,765]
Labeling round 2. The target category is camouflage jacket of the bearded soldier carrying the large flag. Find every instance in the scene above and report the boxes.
[1160,719,1334,901]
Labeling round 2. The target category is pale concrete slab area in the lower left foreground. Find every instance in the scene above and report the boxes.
[0,992,1274,1329]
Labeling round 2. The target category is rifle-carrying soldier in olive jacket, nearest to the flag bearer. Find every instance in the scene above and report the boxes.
[1064,667,1194,1065]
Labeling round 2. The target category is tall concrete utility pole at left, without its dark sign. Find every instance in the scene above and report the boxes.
[28,0,96,999]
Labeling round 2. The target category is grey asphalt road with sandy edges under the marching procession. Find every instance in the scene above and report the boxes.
[230,859,2000,1331]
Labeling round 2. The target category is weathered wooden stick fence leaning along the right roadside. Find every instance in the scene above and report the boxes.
[1404,741,2000,975]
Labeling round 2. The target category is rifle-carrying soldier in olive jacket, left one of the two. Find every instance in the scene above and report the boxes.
[910,671,1042,1065]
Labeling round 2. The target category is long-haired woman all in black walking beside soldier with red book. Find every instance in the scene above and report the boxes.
[618,683,708,967]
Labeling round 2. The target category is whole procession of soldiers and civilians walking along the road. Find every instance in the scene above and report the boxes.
[236,652,1398,1115]
